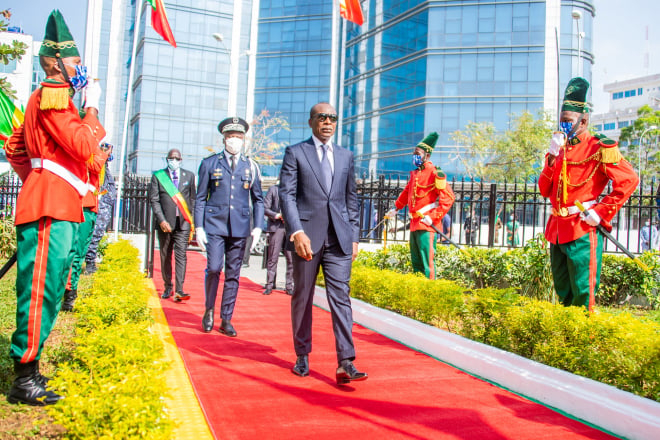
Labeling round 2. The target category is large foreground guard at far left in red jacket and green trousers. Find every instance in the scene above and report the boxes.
[5,11,107,405]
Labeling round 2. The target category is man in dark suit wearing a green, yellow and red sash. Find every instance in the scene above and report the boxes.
[149,148,196,302]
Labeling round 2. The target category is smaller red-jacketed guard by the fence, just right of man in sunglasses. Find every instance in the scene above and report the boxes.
[385,132,454,280]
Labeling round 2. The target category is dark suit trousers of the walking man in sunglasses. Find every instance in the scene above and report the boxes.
[291,226,355,362]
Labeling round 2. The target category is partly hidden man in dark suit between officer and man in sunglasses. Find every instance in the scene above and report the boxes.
[264,181,293,295]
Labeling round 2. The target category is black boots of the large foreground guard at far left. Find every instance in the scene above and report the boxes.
[7,361,63,406]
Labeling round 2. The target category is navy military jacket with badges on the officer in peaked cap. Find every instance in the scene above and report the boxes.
[194,152,264,238]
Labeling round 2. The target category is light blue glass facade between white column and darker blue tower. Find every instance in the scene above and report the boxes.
[254,0,333,175]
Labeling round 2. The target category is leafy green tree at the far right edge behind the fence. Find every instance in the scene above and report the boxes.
[619,105,660,177]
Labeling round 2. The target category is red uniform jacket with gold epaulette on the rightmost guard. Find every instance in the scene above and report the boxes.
[539,132,639,244]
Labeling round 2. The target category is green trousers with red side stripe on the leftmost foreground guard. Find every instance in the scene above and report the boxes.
[9,217,79,363]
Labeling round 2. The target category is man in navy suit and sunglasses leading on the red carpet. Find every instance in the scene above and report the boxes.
[280,102,367,384]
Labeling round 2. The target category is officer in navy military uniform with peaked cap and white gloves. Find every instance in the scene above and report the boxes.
[193,117,264,337]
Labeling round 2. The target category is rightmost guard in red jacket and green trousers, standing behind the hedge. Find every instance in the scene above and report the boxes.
[539,77,639,311]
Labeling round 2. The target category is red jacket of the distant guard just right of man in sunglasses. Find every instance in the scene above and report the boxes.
[394,161,454,232]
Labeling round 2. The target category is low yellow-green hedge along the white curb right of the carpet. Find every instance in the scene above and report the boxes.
[351,264,660,401]
